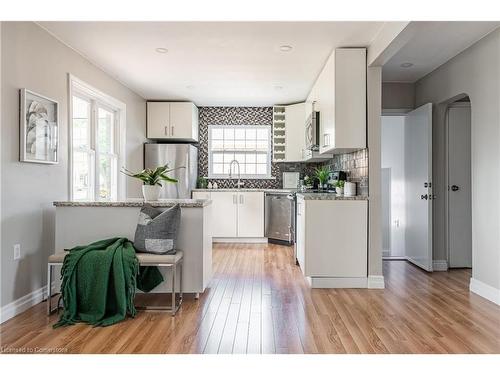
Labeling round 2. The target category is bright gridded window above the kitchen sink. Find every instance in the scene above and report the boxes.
[208,125,271,178]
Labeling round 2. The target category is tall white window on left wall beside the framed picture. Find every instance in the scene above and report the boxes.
[70,75,125,200]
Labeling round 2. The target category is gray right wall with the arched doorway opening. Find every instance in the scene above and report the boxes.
[415,29,500,289]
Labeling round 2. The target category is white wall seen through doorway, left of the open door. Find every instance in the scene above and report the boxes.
[382,116,405,256]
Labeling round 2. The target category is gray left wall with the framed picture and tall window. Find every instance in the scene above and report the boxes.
[1,22,146,306]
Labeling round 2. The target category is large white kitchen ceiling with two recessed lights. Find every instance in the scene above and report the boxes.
[38,22,384,106]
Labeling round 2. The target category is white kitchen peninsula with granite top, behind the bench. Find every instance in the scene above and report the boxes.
[54,199,212,293]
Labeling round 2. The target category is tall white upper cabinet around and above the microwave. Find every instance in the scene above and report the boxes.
[306,48,366,154]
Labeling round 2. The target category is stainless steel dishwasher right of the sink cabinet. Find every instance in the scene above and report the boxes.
[264,192,295,245]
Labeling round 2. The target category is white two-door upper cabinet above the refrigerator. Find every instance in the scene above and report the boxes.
[147,102,198,142]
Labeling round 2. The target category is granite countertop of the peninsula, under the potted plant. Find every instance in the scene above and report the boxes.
[54,199,212,208]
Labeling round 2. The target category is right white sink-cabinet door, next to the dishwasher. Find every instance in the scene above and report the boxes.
[238,192,264,237]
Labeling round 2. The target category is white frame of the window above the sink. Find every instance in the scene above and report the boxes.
[207,124,273,180]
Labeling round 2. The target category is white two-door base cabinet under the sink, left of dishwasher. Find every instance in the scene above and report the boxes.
[192,191,264,238]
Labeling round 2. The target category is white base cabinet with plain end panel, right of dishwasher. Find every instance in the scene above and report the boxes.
[296,195,368,288]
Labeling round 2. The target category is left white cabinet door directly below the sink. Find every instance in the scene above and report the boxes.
[210,191,238,237]
